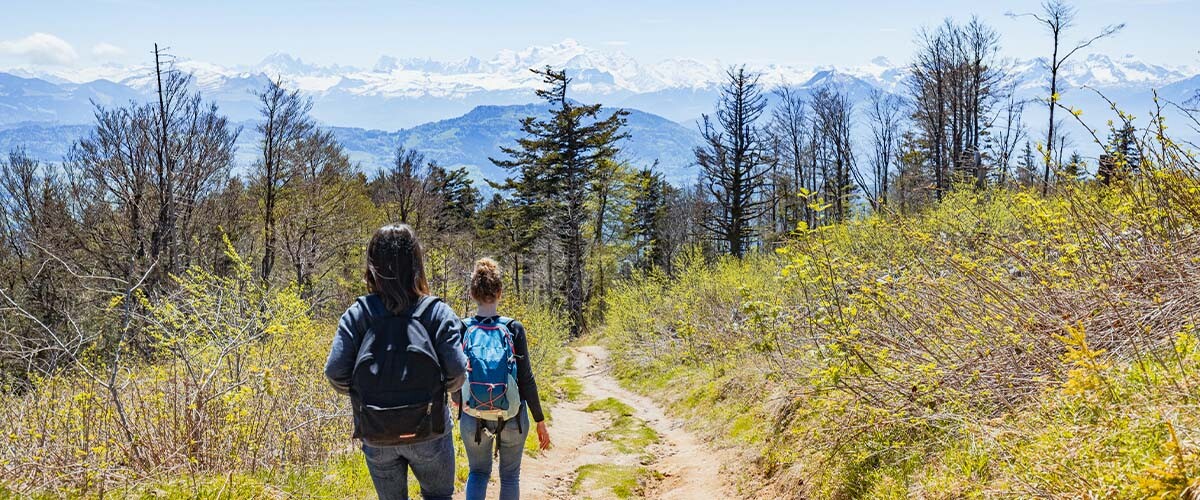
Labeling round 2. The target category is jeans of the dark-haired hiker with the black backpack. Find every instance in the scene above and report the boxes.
[362,432,454,500]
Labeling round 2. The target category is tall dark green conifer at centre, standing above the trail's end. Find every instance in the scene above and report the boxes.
[492,66,629,337]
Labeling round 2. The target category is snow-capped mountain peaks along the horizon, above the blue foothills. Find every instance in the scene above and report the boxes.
[0,40,1198,128]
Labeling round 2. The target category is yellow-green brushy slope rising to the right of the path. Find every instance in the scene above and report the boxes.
[607,179,1200,498]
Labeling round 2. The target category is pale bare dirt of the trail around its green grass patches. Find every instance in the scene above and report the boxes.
[518,345,736,499]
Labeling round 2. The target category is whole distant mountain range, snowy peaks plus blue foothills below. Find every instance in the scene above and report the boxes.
[0,40,1200,181]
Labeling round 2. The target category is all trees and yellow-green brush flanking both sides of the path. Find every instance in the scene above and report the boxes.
[0,0,1200,498]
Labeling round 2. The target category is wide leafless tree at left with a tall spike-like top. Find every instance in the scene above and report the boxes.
[65,51,239,288]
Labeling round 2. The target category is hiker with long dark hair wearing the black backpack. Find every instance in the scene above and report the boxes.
[325,224,468,500]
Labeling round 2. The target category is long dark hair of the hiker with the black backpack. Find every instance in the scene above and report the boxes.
[365,224,430,314]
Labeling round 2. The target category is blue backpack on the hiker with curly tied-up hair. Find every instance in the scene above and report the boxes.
[462,318,521,424]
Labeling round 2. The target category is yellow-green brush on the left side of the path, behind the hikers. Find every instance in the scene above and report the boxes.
[0,239,568,496]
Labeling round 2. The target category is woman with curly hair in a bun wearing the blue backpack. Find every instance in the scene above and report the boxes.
[452,259,550,500]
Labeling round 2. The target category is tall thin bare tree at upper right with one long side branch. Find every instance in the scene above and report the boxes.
[1009,0,1124,195]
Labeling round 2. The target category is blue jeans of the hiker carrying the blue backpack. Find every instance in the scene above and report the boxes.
[458,404,529,500]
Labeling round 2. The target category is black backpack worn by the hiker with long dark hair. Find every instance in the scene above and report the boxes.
[350,295,445,446]
